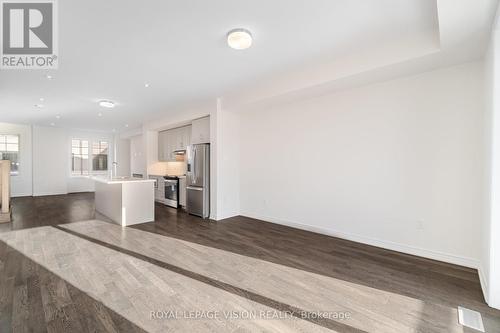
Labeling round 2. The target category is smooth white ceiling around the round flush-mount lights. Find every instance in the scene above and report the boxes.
[0,0,496,131]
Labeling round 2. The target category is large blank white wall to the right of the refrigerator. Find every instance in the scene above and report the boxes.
[239,63,484,267]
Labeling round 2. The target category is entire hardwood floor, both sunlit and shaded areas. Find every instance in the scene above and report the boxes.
[0,193,500,332]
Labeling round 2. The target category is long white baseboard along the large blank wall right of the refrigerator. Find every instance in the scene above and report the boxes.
[241,212,480,269]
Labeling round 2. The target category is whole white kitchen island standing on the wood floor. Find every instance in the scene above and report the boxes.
[94,177,155,227]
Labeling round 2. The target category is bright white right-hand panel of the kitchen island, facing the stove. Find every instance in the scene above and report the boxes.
[122,182,155,225]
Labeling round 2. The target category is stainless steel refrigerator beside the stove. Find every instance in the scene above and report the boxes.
[186,144,210,218]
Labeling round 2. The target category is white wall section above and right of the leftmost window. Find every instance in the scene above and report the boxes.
[0,123,33,197]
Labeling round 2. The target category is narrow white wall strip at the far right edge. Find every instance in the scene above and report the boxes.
[480,22,500,308]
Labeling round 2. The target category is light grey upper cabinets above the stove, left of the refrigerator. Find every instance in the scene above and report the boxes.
[158,125,191,162]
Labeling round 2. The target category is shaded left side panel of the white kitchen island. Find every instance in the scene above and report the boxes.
[95,181,123,225]
